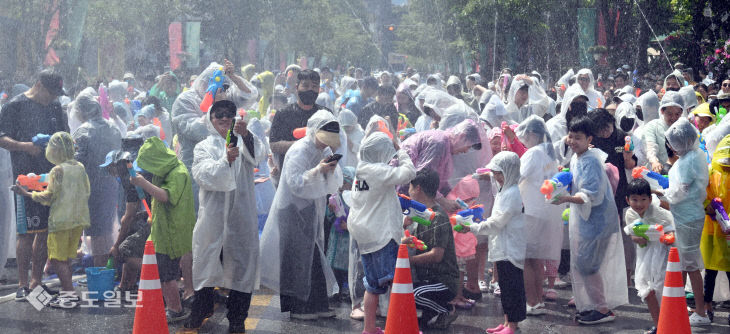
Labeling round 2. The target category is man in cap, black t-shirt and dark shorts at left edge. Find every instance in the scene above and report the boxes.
[0,70,69,301]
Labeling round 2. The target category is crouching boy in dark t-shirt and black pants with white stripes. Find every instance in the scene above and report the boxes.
[401,168,459,329]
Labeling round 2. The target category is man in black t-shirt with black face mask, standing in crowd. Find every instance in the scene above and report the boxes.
[269,70,331,176]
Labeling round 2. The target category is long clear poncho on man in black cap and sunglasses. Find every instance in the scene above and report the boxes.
[191,107,265,293]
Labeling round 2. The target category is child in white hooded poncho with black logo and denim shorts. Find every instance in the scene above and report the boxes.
[347,132,416,333]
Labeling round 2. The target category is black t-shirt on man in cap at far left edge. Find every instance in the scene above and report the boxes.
[0,94,69,178]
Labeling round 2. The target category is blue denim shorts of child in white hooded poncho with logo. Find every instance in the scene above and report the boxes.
[361,240,398,295]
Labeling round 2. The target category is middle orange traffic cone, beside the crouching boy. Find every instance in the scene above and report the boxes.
[385,244,421,334]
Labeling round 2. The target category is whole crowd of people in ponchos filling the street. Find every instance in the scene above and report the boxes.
[0,60,730,334]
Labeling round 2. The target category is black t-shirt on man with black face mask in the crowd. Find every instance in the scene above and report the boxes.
[269,103,332,167]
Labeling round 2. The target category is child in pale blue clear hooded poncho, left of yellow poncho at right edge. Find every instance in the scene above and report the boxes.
[664,117,712,326]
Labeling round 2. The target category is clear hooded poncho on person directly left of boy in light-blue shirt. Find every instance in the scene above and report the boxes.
[515,115,563,260]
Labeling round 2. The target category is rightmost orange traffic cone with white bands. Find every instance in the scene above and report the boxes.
[657,247,692,334]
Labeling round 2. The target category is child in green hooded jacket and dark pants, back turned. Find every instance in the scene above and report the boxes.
[130,137,195,322]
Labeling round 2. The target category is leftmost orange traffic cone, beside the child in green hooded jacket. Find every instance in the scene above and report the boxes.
[132,240,170,334]
